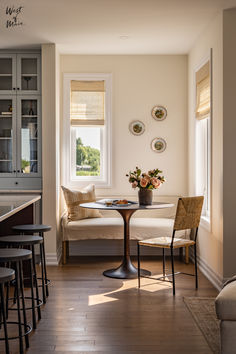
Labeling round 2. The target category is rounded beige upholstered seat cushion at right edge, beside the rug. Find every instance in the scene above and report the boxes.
[215,281,236,321]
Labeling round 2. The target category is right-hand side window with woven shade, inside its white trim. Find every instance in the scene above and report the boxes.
[195,60,211,222]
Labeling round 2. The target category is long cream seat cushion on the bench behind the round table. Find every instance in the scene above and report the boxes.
[62,216,187,241]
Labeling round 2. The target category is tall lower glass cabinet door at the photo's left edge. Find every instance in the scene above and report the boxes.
[0,95,16,176]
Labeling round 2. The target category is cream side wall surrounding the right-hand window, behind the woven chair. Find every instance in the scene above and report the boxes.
[188,14,223,285]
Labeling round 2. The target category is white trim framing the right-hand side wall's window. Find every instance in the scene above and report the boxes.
[193,48,213,232]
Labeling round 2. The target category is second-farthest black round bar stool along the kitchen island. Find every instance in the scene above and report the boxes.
[0,235,43,329]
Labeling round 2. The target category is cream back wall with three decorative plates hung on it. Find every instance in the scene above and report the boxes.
[60,55,188,199]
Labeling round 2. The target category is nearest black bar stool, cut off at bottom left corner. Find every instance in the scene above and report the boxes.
[0,267,15,354]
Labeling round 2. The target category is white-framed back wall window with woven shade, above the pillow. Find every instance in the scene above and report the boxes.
[63,74,111,187]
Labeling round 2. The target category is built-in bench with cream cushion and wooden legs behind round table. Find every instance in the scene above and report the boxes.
[61,196,188,264]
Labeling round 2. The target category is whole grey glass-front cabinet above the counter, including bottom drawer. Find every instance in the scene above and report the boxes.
[0,53,41,190]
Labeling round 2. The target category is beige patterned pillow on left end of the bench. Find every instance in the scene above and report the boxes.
[61,184,102,220]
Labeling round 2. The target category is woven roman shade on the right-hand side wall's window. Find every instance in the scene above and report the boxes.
[196,61,211,120]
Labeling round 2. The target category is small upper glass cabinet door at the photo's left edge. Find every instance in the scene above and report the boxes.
[0,54,16,94]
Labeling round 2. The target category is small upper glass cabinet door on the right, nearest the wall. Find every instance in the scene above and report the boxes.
[17,54,40,95]
